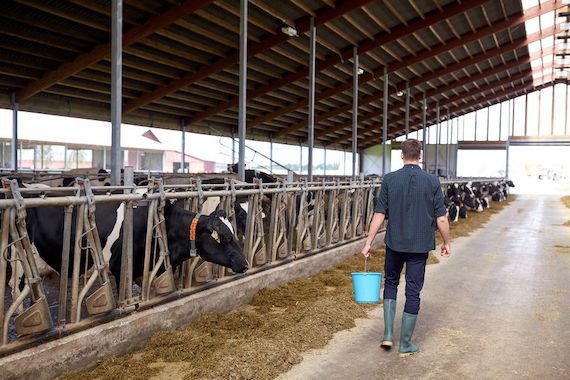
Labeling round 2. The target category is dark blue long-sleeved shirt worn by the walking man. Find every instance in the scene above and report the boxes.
[374,164,447,253]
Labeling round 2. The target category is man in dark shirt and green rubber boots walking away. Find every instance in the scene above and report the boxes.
[362,139,451,357]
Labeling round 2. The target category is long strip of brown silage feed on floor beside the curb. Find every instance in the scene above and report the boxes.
[66,197,512,380]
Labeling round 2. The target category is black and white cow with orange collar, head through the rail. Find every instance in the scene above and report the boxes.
[27,202,249,284]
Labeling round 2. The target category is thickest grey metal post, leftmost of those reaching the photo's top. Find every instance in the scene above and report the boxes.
[111,0,123,185]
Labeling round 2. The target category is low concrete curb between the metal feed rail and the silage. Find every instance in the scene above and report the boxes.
[0,234,383,380]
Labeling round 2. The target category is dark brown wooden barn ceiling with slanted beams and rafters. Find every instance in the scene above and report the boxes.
[0,0,570,148]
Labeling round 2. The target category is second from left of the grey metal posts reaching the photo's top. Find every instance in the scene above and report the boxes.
[238,0,248,181]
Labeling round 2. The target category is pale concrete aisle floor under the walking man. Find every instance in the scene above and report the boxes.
[280,195,570,380]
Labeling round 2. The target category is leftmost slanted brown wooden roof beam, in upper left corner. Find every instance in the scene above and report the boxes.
[16,0,213,102]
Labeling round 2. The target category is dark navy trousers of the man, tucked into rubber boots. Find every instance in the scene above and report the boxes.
[384,246,428,314]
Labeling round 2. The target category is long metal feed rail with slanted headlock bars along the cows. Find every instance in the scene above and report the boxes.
[0,179,502,355]
